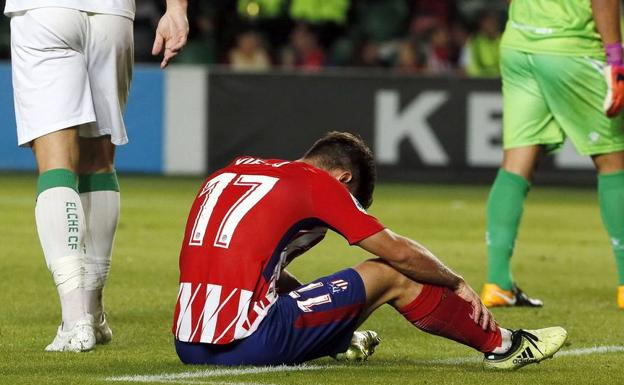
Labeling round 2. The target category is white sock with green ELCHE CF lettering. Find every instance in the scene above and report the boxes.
[35,187,86,330]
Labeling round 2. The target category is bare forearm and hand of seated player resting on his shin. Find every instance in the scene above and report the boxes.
[358,229,496,330]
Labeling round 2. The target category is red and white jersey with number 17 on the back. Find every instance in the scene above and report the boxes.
[172,157,383,344]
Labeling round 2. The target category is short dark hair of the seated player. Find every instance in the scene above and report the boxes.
[303,131,376,208]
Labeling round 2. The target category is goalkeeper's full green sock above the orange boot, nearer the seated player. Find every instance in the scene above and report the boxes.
[486,169,529,290]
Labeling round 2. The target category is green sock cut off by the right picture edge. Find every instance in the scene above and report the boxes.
[598,171,624,285]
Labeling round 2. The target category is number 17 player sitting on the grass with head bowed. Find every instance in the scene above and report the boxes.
[173,132,567,369]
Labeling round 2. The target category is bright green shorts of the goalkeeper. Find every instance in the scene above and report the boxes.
[501,48,624,155]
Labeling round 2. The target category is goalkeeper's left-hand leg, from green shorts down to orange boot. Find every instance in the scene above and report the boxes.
[481,49,552,307]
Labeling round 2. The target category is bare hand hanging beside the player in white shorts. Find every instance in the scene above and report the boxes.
[152,6,189,68]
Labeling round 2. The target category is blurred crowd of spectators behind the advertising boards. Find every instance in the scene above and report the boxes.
[0,0,507,77]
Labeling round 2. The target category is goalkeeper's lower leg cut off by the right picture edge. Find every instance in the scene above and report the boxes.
[592,151,624,309]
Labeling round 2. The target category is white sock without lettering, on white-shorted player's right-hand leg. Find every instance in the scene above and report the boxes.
[80,190,120,321]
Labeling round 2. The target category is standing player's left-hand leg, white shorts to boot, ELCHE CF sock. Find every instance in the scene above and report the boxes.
[11,7,101,351]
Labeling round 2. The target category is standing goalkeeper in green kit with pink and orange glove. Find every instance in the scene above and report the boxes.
[481,0,624,309]
